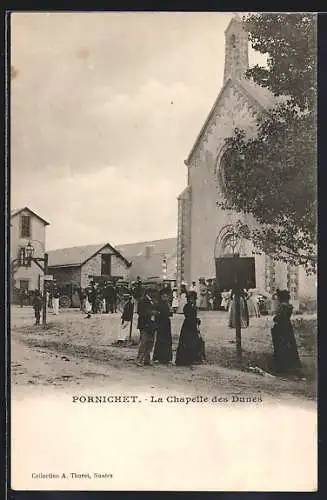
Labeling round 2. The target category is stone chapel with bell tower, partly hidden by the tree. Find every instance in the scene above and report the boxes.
[177,16,316,307]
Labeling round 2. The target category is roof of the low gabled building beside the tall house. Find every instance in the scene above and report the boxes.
[48,243,129,267]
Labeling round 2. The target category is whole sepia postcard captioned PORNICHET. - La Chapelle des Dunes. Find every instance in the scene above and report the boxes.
[8,11,318,492]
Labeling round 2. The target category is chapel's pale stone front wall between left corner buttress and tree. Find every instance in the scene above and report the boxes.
[186,82,260,282]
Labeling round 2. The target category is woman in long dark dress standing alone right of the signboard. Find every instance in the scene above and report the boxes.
[271,290,302,377]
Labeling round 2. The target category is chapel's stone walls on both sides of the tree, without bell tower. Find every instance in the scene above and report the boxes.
[178,77,316,309]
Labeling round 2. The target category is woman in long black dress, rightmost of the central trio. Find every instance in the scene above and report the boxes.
[175,292,202,366]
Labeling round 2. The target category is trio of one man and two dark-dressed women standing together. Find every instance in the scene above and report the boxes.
[136,289,205,366]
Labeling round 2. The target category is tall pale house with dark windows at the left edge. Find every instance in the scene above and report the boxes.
[10,207,49,290]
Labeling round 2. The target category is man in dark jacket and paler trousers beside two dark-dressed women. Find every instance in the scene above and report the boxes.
[136,292,156,366]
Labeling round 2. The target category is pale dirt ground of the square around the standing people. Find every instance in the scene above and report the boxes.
[11,307,315,402]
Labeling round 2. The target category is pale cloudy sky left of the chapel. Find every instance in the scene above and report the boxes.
[11,12,262,250]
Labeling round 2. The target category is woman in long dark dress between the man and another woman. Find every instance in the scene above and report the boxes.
[153,290,173,365]
